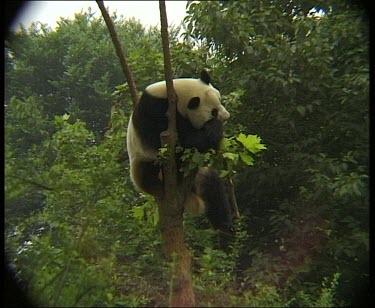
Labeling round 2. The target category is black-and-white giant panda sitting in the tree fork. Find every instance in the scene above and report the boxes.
[127,70,233,232]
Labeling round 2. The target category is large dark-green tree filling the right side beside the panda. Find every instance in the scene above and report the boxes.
[186,1,369,299]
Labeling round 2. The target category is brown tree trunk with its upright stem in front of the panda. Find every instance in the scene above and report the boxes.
[158,0,195,307]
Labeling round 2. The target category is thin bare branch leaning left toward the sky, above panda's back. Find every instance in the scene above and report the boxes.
[96,1,138,109]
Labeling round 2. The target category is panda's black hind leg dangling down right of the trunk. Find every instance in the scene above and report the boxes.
[195,168,233,233]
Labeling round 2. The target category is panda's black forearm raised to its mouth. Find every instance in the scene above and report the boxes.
[179,118,223,152]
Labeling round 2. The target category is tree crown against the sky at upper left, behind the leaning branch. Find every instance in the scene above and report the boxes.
[5,10,167,136]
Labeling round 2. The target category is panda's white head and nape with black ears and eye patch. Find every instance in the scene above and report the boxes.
[147,70,230,129]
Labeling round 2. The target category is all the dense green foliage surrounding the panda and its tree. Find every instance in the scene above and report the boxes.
[5,0,369,307]
